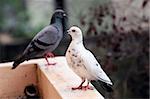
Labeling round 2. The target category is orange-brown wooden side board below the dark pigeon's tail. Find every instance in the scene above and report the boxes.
[0,64,37,99]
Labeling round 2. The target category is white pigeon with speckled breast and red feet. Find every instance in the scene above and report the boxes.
[66,26,113,92]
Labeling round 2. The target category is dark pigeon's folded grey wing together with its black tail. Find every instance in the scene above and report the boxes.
[12,26,59,69]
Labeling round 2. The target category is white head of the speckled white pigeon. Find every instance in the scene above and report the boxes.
[67,26,82,40]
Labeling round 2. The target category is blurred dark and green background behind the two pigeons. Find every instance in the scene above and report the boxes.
[0,0,150,99]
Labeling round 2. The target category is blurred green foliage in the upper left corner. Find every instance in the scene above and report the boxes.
[0,0,41,38]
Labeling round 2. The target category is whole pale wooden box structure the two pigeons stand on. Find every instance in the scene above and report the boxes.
[0,57,104,99]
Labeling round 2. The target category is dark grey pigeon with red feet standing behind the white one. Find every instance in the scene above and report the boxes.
[12,9,66,69]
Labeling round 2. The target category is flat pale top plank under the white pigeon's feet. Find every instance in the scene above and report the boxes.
[38,57,104,99]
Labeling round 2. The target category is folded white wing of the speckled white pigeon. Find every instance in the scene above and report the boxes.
[81,50,112,85]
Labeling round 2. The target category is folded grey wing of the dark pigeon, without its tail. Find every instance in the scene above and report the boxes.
[24,26,59,56]
